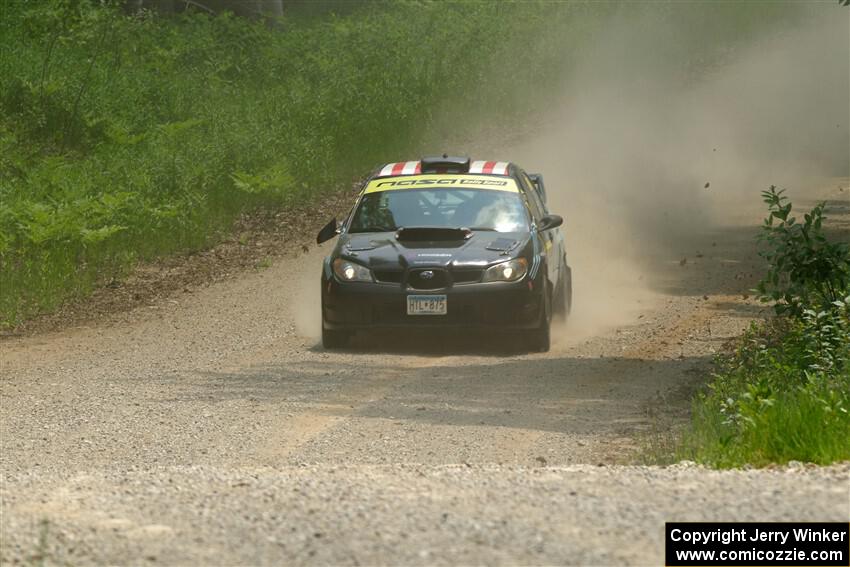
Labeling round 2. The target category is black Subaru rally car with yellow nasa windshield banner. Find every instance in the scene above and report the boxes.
[316,156,572,351]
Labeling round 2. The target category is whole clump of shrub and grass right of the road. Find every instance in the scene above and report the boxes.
[678,187,850,467]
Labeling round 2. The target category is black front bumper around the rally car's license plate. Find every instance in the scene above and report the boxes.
[322,277,545,330]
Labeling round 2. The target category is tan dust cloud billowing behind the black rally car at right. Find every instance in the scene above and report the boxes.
[495,3,850,338]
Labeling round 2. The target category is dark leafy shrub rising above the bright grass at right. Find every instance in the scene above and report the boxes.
[757,187,850,317]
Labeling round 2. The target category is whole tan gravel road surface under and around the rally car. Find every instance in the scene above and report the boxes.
[0,184,850,565]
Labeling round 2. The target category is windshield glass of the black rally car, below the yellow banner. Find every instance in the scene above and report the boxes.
[349,188,528,232]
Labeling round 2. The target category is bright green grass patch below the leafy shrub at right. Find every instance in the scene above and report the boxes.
[674,310,850,468]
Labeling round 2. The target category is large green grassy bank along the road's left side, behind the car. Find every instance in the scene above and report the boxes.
[0,0,808,326]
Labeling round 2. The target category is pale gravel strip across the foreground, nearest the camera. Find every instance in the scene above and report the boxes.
[4,465,850,565]
